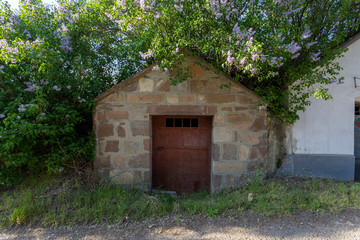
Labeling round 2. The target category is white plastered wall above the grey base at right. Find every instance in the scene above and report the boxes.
[287,35,360,155]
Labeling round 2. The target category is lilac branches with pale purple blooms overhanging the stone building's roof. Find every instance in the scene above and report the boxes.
[89,0,360,123]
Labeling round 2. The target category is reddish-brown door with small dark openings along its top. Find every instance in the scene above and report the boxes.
[152,116,212,193]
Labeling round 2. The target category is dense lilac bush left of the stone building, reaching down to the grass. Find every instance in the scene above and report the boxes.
[0,0,141,186]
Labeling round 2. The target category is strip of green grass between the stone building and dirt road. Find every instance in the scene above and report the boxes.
[0,173,360,228]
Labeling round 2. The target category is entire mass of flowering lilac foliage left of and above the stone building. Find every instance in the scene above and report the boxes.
[0,0,360,186]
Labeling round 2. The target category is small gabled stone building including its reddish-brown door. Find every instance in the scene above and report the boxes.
[94,56,269,192]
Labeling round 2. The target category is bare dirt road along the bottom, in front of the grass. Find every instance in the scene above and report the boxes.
[0,210,360,240]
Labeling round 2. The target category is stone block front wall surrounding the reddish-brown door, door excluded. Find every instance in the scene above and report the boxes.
[94,57,268,192]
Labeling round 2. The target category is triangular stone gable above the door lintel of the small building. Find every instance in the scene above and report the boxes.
[95,56,260,103]
